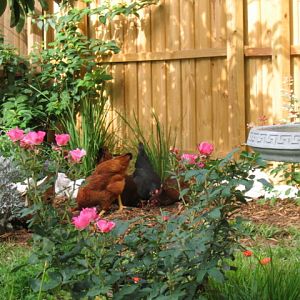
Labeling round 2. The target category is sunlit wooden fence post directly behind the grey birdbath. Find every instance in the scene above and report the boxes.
[272,0,291,122]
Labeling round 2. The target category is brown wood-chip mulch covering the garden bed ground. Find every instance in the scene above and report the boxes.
[0,200,300,245]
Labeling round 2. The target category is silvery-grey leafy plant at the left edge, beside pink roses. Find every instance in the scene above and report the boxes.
[0,156,24,233]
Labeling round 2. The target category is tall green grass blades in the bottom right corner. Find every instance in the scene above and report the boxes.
[206,247,300,300]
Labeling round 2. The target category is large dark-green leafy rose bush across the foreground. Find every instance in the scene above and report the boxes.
[15,152,260,299]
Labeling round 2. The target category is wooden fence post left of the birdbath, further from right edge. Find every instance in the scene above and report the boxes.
[226,0,246,147]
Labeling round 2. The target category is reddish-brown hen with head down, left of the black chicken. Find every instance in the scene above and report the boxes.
[76,153,132,211]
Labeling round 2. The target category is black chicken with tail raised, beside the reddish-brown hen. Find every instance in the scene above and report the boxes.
[133,143,162,200]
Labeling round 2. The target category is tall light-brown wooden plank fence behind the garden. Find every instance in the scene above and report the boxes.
[0,0,300,154]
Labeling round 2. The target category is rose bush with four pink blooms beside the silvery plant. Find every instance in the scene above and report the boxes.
[7,128,85,226]
